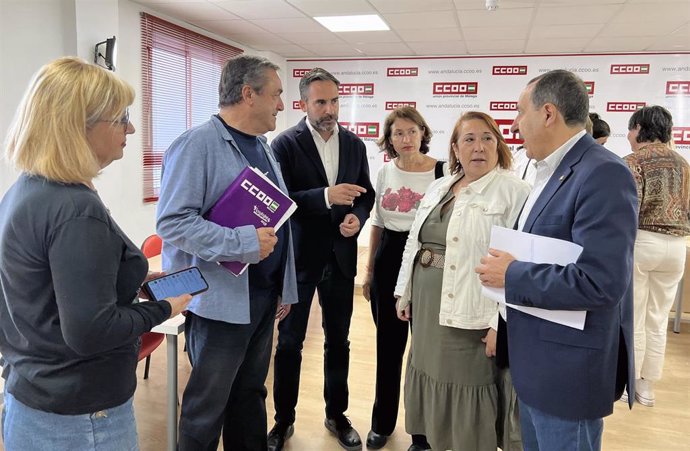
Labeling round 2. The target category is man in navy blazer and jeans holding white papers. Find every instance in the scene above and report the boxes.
[477,70,637,451]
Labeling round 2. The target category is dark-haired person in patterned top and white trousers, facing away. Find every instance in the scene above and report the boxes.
[625,106,690,407]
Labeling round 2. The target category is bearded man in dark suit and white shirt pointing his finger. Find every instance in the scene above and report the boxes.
[268,68,374,451]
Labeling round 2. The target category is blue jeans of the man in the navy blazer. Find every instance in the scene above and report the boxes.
[518,399,604,451]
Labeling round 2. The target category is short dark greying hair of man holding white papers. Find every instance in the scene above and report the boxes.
[527,69,589,127]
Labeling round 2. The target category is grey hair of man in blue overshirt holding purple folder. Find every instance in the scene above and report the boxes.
[218,55,280,107]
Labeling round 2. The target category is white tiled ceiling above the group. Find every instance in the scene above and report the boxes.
[134,0,690,58]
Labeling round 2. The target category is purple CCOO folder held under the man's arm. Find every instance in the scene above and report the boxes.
[205,166,297,276]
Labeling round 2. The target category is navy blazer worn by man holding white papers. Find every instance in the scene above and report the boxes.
[505,135,637,420]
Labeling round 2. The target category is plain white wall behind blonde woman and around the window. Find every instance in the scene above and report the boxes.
[0,0,286,247]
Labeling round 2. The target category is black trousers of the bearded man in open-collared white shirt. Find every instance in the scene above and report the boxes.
[273,254,354,424]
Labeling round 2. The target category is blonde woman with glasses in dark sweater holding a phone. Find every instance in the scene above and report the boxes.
[0,57,191,451]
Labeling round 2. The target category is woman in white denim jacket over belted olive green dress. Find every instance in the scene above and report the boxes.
[395,112,530,451]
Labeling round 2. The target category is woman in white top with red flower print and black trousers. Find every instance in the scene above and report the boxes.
[362,106,444,451]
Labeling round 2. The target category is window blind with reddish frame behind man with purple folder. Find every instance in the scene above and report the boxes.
[141,13,243,203]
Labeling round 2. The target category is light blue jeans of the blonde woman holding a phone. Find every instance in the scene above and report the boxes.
[2,392,139,451]
